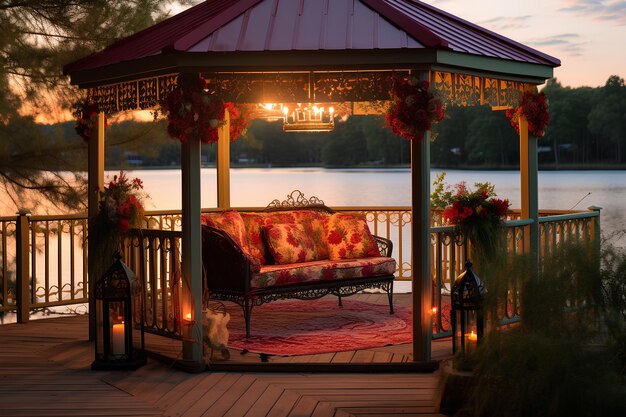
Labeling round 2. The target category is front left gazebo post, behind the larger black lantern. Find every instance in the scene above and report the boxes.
[180,134,205,371]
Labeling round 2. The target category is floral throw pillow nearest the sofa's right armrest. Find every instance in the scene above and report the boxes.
[324,213,380,260]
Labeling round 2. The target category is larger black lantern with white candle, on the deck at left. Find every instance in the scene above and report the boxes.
[91,252,146,369]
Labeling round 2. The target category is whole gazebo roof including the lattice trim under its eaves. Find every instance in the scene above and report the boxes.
[64,0,560,112]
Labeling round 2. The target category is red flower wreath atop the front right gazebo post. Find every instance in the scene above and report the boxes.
[385,76,444,140]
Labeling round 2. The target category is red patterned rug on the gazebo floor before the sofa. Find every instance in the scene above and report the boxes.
[228,297,412,355]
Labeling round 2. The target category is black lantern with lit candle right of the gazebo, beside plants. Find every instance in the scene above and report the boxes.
[451,262,487,353]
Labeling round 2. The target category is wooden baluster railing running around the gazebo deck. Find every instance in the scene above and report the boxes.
[0,207,600,337]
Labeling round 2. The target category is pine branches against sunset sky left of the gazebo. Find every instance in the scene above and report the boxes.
[0,0,188,211]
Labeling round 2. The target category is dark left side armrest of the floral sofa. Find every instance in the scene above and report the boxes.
[202,225,252,296]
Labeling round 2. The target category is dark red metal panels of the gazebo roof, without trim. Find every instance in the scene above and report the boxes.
[64,0,560,73]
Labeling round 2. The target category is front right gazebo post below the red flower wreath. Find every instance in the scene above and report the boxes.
[411,79,432,362]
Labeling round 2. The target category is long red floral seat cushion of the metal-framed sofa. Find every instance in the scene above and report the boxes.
[251,256,396,288]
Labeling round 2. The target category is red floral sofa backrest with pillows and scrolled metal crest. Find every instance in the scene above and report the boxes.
[202,191,380,271]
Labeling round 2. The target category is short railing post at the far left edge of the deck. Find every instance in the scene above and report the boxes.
[15,210,30,323]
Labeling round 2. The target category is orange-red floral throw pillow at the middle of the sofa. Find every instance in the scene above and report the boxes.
[263,223,318,265]
